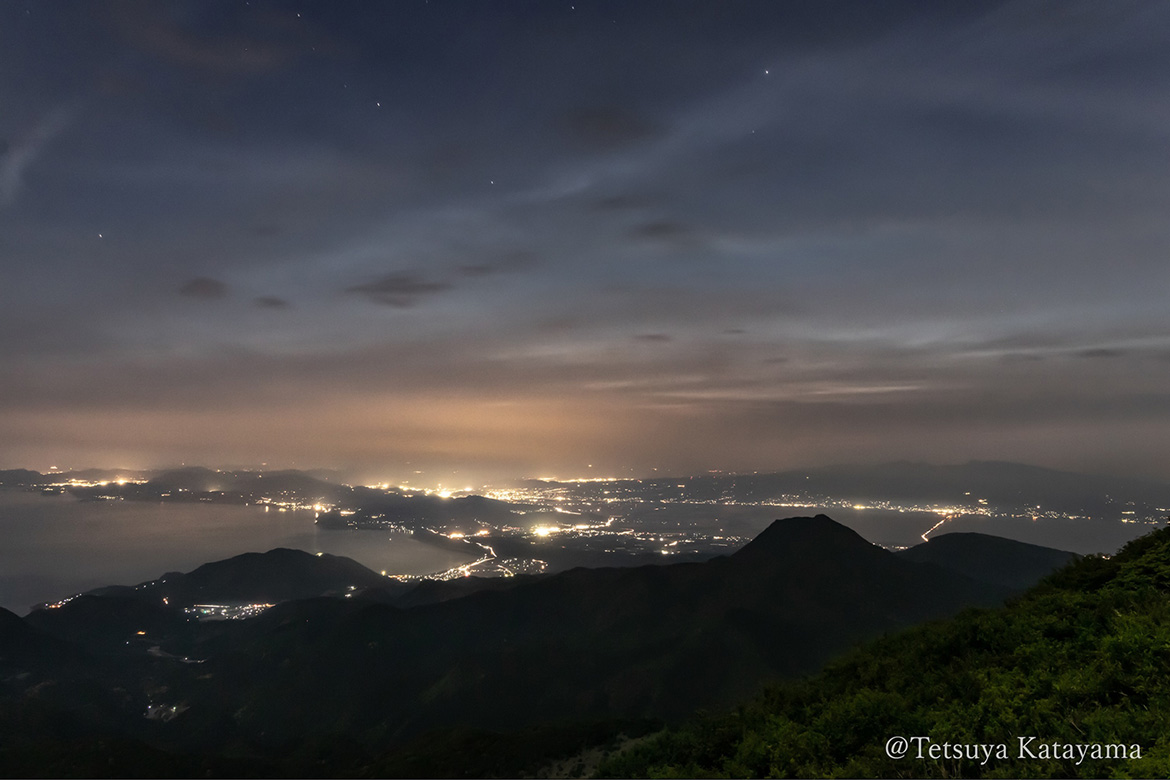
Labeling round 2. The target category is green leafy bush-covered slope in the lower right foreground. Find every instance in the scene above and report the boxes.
[601,530,1170,778]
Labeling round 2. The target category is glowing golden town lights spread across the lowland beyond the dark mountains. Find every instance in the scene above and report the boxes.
[18,469,1170,591]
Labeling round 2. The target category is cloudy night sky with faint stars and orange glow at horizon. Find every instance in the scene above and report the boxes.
[0,0,1170,484]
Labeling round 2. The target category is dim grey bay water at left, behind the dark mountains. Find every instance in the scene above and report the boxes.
[0,488,472,615]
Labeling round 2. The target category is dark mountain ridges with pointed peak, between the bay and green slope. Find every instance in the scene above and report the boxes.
[0,516,1068,775]
